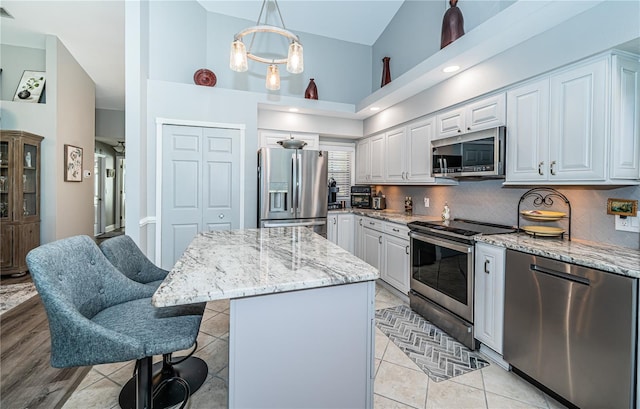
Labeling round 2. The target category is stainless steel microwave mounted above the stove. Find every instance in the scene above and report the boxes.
[431,126,506,178]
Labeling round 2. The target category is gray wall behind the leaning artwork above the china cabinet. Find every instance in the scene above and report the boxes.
[0,44,46,102]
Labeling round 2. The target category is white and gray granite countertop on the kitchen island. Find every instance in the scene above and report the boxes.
[152,227,380,307]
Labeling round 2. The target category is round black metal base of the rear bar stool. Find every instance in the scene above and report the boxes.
[118,354,208,409]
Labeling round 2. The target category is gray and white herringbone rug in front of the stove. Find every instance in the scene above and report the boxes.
[376,305,489,382]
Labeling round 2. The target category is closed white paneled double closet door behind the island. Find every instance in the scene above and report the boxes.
[160,125,241,269]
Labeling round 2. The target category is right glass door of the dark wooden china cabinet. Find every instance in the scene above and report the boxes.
[16,143,40,220]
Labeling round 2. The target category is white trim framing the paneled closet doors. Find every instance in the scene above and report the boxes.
[154,118,246,266]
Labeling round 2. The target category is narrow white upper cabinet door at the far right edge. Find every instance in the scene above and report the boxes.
[610,55,640,179]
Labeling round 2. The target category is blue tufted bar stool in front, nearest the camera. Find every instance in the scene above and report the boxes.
[27,236,202,409]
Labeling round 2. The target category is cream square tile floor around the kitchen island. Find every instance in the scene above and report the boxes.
[63,285,564,409]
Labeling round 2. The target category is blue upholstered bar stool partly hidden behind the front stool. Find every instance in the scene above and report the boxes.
[100,235,208,409]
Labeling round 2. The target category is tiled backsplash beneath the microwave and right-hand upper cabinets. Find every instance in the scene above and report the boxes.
[377,180,640,249]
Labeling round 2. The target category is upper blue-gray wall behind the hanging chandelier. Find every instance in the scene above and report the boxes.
[149,1,371,104]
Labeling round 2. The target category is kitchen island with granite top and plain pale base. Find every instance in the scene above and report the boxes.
[152,227,379,408]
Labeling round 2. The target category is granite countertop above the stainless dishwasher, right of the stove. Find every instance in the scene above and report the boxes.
[474,233,640,278]
